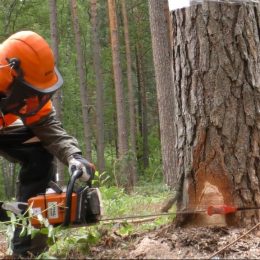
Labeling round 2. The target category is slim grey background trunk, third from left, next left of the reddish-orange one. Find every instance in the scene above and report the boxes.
[91,0,105,173]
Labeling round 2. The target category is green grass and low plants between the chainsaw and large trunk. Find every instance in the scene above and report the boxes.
[41,185,172,259]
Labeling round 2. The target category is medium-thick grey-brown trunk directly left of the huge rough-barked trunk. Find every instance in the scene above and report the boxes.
[149,0,176,187]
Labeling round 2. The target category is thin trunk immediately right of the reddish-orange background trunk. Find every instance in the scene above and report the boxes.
[121,0,136,186]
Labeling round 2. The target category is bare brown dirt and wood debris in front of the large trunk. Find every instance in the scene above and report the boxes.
[91,225,260,259]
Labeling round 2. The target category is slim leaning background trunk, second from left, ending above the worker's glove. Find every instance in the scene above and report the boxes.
[70,0,92,161]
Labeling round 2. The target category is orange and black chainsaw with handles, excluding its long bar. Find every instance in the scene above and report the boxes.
[0,170,102,228]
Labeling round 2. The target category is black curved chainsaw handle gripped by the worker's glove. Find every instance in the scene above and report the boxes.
[63,170,83,227]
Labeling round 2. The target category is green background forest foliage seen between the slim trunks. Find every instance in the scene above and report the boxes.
[0,0,162,193]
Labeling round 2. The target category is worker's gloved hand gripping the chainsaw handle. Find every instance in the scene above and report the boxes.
[69,154,96,182]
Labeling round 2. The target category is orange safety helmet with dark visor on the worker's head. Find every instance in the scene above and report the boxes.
[0,31,63,117]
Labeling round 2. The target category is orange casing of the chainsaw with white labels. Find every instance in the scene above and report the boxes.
[28,192,77,227]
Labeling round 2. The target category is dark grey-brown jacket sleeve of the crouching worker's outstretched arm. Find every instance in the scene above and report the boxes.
[27,110,81,165]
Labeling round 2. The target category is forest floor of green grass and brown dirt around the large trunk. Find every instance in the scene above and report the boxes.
[0,183,260,259]
